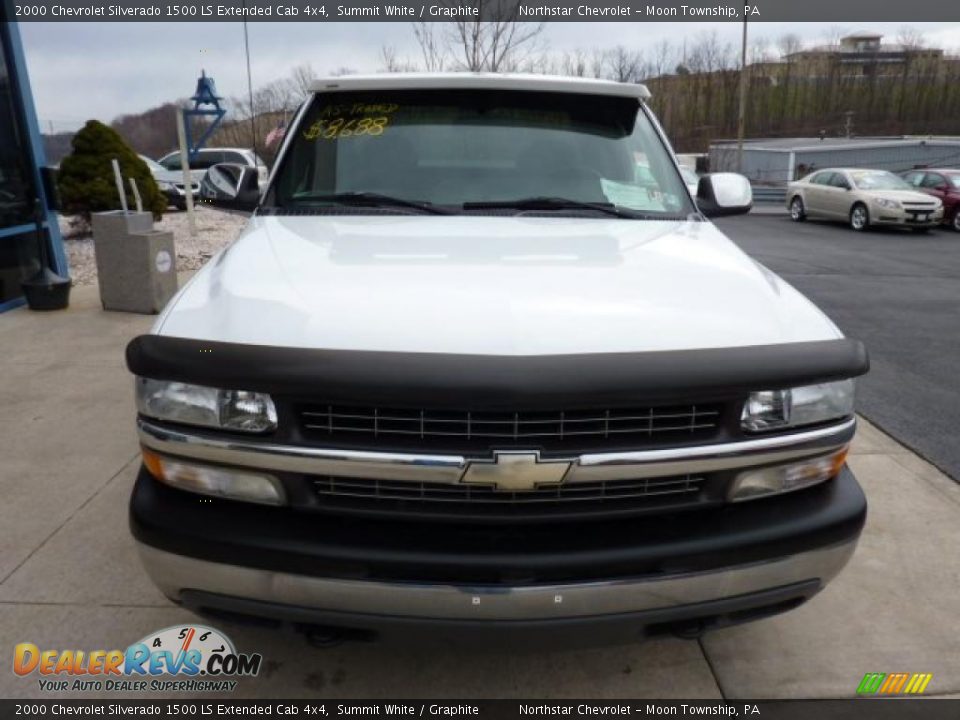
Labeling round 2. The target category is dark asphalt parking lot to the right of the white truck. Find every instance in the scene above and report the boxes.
[717,214,960,481]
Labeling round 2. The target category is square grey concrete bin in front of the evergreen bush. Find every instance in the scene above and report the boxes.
[93,210,177,314]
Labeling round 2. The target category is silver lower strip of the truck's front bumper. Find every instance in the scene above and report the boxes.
[133,540,856,621]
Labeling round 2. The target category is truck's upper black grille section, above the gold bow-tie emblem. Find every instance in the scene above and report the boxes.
[300,404,722,452]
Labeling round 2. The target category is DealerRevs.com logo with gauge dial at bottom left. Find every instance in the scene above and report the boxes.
[13,625,263,692]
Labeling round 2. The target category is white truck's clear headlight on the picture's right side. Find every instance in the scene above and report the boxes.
[740,379,854,432]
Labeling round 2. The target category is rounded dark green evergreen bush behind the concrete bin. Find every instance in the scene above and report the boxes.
[57,120,167,223]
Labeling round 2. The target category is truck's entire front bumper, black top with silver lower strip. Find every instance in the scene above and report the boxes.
[130,468,866,644]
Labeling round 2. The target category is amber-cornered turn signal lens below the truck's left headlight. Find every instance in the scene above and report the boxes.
[143,448,284,505]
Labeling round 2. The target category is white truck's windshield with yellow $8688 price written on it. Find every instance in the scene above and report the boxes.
[265,90,694,217]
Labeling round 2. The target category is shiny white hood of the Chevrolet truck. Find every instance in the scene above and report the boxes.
[154,215,840,355]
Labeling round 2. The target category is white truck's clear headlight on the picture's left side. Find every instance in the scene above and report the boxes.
[136,377,277,432]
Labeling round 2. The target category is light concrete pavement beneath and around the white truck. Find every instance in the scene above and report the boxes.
[0,280,960,698]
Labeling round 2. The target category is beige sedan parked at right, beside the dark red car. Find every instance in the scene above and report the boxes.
[787,168,943,232]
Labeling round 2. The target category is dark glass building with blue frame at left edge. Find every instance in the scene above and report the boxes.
[0,9,67,312]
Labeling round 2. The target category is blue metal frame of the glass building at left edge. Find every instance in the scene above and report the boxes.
[0,9,69,312]
